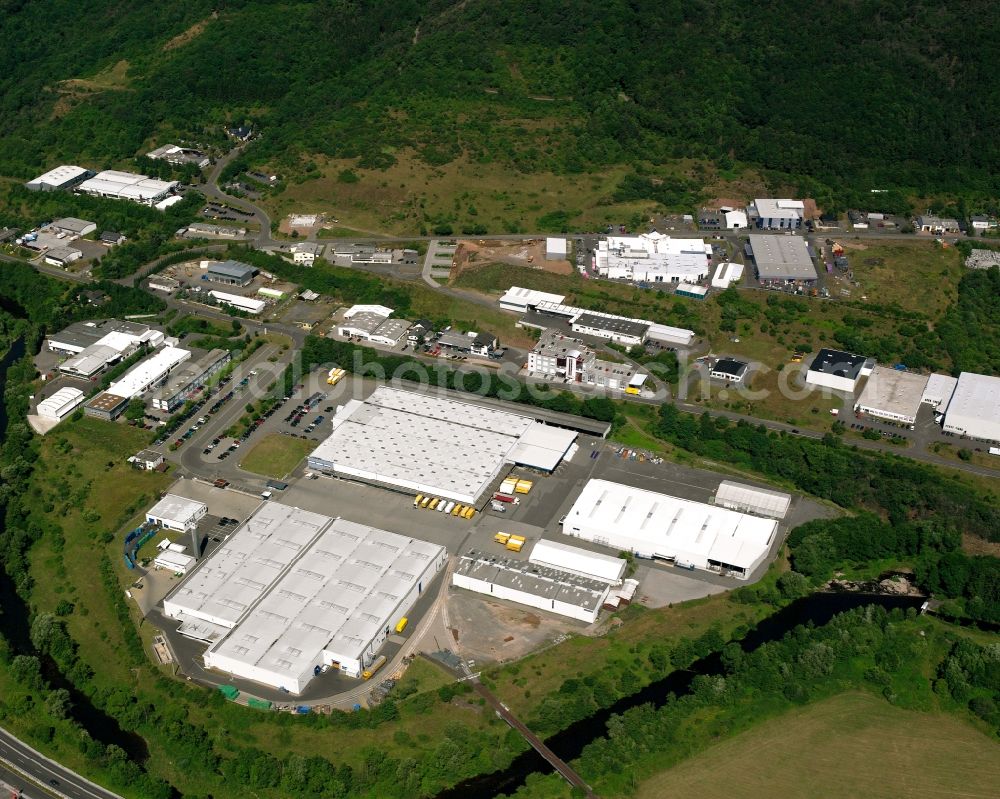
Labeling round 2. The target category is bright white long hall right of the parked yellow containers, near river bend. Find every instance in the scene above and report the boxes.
[563,480,778,579]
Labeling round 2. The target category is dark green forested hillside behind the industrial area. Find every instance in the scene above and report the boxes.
[0,0,1000,206]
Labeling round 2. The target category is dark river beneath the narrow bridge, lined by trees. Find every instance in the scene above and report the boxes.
[436,593,924,799]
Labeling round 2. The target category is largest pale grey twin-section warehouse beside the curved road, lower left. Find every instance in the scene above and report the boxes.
[163,502,447,694]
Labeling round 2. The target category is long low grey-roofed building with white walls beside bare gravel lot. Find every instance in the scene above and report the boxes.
[451,550,611,624]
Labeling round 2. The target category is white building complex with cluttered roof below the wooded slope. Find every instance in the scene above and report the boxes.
[594,232,712,283]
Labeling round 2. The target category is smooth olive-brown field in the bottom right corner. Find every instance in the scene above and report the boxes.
[638,693,1000,799]
